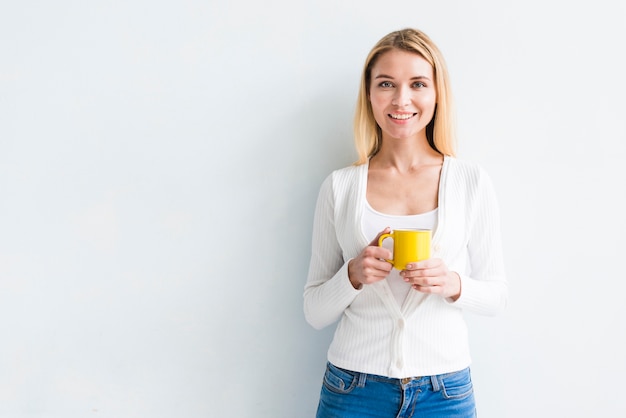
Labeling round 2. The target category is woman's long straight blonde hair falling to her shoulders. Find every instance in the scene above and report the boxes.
[354,28,456,165]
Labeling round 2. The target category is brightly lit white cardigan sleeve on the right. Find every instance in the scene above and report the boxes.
[446,165,508,315]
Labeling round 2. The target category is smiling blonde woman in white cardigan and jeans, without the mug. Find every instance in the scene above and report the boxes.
[304,29,507,418]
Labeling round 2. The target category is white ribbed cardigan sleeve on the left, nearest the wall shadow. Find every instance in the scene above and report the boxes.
[304,175,361,329]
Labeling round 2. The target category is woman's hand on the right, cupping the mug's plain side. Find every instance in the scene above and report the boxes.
[400,258,461,300]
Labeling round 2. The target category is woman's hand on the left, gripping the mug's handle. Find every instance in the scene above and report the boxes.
[348,227,393,289]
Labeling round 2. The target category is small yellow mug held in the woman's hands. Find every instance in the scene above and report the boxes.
[378,229,431,270]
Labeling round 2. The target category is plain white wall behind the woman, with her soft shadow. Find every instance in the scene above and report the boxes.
[0,0,626,418]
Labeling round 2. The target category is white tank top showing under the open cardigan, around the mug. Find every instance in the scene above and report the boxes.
[362,201,437,306]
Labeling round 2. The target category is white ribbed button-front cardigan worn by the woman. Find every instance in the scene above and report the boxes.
[304,157,508,378]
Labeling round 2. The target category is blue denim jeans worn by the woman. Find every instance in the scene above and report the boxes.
[317,363,476,418]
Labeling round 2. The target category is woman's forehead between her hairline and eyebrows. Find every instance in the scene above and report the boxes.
[371,49,433,79]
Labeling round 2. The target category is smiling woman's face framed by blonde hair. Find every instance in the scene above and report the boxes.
[369,49,437,141]
